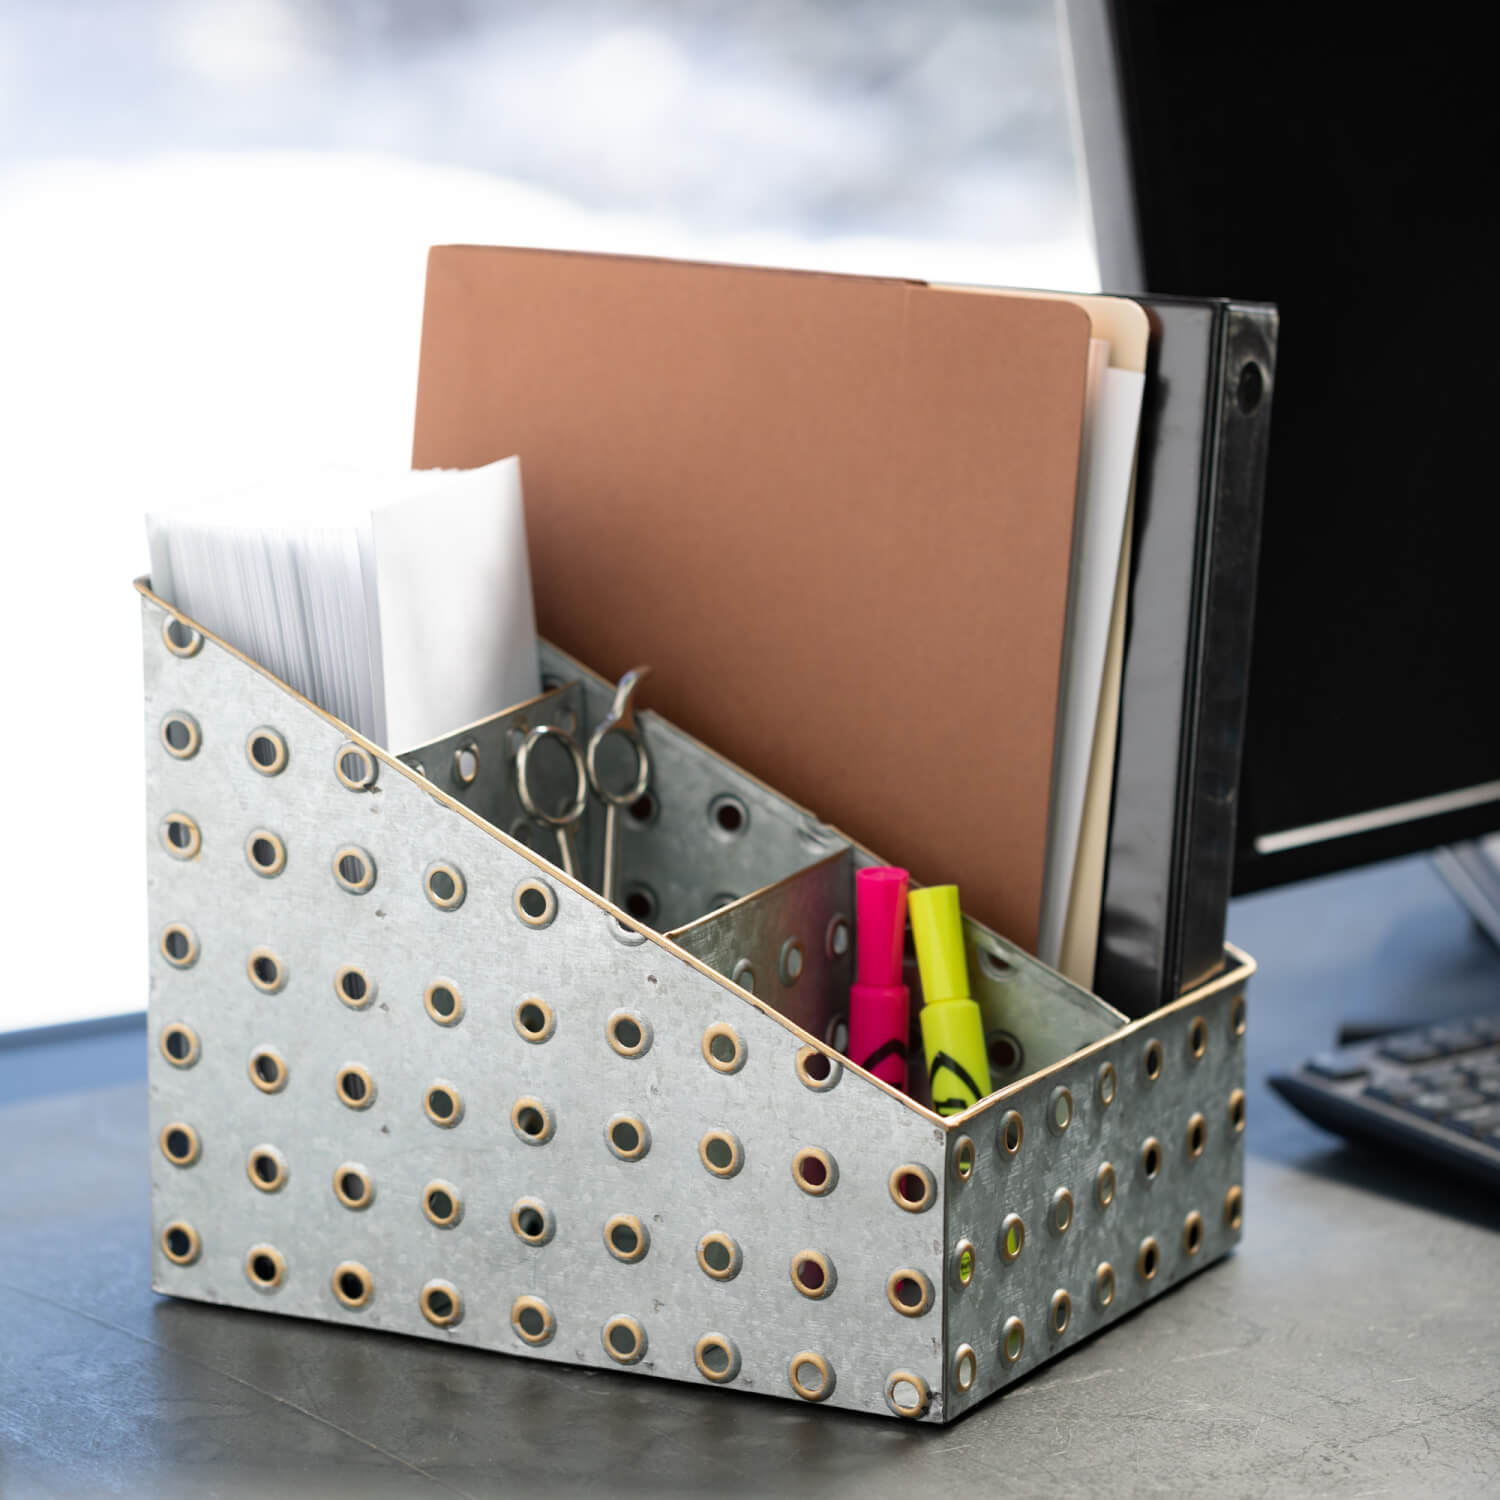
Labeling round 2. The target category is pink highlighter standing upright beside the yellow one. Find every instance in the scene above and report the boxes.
[849,864,912,1092]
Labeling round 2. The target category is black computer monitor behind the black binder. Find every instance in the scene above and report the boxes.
[1070,0,1500,891]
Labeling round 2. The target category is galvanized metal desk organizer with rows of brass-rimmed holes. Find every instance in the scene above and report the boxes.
[146,582,1254,1424]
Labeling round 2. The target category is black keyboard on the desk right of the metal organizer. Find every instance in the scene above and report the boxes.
[1271,1016,1500,1187]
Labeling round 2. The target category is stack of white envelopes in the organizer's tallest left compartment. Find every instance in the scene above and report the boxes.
[147,458,537,750]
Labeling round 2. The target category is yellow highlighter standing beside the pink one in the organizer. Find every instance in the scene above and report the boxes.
[906,885,990,1115]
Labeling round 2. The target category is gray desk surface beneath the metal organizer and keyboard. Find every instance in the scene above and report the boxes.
[0,861,1500,1500]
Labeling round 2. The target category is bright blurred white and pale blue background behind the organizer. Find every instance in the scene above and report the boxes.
[0,0,1098,1029]
